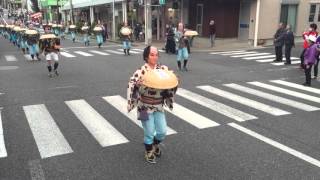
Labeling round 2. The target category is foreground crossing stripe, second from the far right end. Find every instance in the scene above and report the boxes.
[247,81,320,103]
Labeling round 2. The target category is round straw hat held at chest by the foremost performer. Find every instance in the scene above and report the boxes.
[142,69,178,90]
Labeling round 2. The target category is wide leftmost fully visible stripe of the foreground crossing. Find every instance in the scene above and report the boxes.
[23,104,73,158]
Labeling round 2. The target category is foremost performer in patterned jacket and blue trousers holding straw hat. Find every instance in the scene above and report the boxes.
[127,46,178,163]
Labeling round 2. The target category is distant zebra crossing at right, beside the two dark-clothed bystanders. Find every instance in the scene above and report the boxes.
[209,50,300,66]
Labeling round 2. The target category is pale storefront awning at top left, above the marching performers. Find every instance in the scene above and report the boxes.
[62,0,124,10]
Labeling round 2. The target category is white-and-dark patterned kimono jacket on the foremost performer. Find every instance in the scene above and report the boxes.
[127,63,177,120]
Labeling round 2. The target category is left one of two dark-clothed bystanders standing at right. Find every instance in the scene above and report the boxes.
[273,23,286,62]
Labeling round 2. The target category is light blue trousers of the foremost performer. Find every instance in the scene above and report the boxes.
[141,111,167,144]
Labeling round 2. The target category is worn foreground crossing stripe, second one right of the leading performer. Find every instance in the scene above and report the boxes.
[177,88,258,122]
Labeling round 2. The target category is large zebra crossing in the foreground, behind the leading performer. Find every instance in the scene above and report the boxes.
[0,80,320,159]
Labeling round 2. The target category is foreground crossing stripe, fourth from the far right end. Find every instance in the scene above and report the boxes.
[197,86,291,116]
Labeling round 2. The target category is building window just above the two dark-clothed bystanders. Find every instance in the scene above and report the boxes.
[280,4,298,32]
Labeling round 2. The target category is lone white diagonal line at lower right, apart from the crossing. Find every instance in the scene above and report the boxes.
[228,123,320,167]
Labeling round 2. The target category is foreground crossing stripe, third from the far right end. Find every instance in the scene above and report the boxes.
[224,83,320,111]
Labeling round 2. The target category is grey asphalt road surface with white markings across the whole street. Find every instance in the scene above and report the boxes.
[0,35,320,180]
